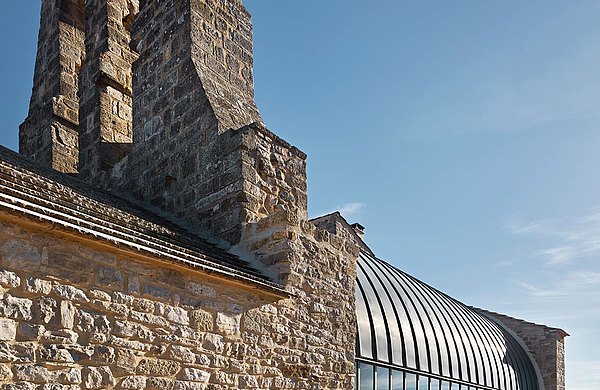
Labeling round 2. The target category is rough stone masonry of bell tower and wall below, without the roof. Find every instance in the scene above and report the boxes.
[11,0,358,390]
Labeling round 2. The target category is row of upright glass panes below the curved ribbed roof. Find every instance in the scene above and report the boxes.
[356,362,484,390]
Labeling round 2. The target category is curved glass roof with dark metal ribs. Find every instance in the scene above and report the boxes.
[356,252,540,390]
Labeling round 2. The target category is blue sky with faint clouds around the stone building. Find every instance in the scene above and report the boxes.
[0,0,600,390]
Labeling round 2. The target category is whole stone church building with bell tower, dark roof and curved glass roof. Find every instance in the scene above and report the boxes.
[0,0,566,390]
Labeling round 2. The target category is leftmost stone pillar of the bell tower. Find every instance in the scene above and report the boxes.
[19,0,85,173]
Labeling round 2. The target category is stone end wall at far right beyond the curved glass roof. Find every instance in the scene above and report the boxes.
[477,309,567,390]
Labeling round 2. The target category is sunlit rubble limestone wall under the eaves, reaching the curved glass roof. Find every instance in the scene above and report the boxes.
[0,213,356,390]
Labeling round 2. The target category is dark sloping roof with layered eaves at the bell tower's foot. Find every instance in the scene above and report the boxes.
[0,146,286,294]
